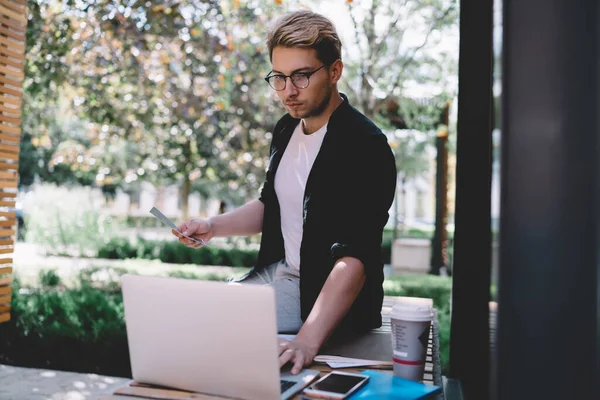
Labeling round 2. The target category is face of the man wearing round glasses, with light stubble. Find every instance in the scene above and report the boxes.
[271,46,334,118]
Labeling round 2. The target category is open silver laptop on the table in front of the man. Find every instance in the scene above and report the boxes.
[121,274,319,400]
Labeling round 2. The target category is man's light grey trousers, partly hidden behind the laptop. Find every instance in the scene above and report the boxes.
[235,260,302,333]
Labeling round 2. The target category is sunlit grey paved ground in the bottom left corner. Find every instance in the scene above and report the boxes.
[0,364,129,400]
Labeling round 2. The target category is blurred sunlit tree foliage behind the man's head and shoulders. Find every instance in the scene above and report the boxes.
[19,0,457,216]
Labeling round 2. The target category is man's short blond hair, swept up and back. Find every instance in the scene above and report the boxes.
[267,10,342,65]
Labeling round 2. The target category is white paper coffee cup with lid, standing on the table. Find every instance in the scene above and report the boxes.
[390,297,433,381]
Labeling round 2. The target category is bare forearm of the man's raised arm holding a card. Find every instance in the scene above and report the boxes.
[210,200,265,237]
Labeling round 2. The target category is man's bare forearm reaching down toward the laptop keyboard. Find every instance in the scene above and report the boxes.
[297,257,365,348]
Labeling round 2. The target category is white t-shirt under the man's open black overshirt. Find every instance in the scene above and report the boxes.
[275,122,327,270]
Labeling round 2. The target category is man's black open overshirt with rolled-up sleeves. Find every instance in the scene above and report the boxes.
[255,95,396,332]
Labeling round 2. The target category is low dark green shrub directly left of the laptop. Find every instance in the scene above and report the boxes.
[0,270,130,376]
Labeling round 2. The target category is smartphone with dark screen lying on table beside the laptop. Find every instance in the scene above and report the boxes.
[302,371,369,399]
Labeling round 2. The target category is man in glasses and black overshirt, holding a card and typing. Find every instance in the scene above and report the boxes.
[174,11,396,373]
